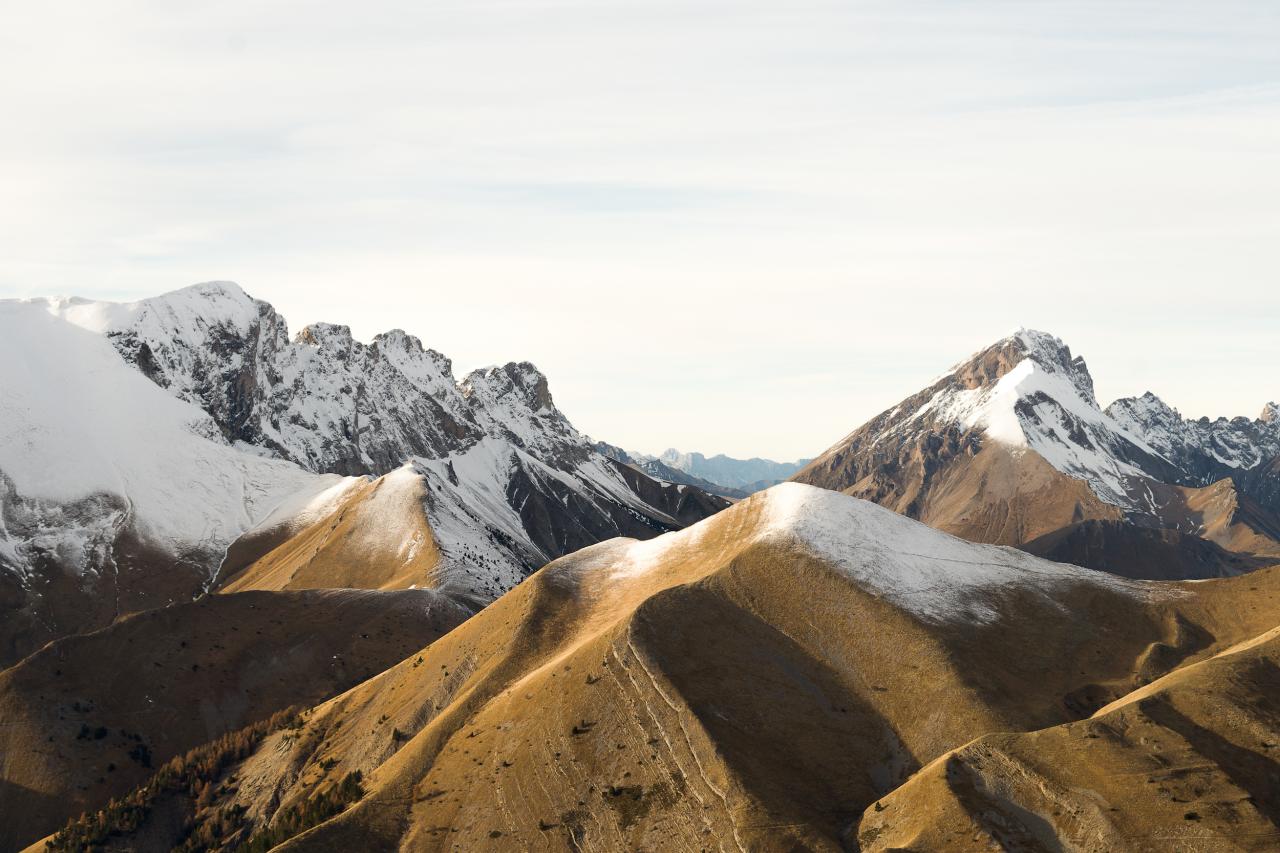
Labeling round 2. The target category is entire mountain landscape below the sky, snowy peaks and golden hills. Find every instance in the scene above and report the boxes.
[0,283,1280,853]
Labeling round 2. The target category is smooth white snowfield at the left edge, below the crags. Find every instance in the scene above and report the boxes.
[0,295,326,571]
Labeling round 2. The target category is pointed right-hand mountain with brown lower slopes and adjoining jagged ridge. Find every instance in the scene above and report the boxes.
[795,330,1280,576]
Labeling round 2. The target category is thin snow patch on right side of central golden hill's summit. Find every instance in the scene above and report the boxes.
[752,483,1152,622]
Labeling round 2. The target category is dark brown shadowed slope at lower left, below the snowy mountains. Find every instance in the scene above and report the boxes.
[0,590,466,849]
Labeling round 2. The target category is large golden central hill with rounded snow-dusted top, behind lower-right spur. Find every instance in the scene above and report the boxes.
[77,485,1280,850]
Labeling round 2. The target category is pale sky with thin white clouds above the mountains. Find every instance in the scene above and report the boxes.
[0,0,1280,459]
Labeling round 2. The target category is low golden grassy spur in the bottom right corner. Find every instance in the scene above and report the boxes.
[859,617,1280,853]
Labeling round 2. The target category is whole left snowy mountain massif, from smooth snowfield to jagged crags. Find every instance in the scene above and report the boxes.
[0,283,724,665]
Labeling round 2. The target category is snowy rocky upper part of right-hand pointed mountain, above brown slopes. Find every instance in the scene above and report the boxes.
[797,329,1280,510]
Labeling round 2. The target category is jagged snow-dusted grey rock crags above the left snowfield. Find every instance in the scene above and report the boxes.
[110,283,588,474]
